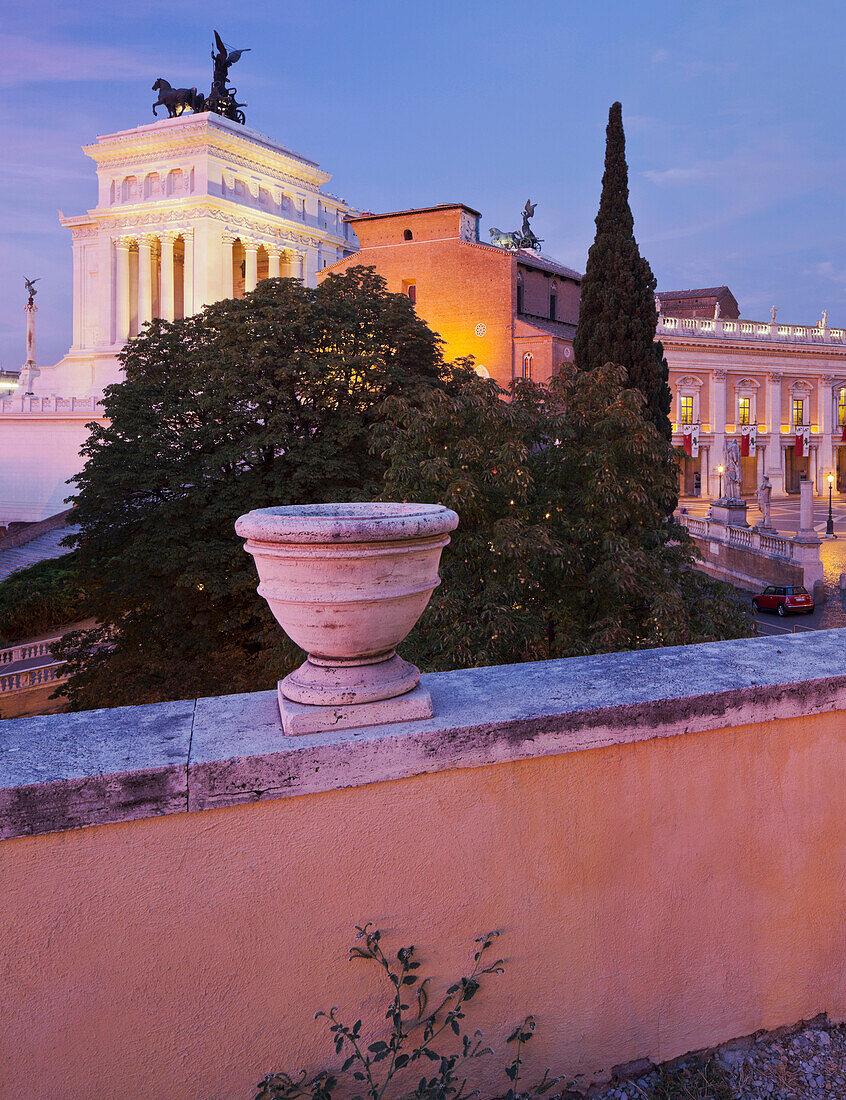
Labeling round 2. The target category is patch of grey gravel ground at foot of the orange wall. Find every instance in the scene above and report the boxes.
[595,1020,846,1100]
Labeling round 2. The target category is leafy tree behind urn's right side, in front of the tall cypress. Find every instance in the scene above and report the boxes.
[374,364,750,669]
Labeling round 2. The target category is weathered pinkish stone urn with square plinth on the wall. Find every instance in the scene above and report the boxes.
[235,504,459,733]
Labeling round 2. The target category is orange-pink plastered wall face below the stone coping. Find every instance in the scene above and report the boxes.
[0,713,846,1100]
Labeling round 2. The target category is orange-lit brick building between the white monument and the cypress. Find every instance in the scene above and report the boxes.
[319,204,581,386]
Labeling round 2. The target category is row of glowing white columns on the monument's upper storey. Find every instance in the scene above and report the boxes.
[112,226,307,343]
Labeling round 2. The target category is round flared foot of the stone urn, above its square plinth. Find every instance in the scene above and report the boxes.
[279,649,420,706]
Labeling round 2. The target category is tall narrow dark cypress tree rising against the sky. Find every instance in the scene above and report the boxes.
[573,103,672,443]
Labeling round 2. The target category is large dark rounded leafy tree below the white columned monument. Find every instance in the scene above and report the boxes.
[55,267,443,707]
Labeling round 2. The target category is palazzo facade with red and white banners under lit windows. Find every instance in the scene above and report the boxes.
[657,315,846,499]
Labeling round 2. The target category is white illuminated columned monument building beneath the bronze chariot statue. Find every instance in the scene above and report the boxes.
[0,113,358,523]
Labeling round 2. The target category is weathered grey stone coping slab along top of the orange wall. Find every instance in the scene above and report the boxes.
[0,629,846,839]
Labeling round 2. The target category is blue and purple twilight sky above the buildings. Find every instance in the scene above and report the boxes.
[0,0,846,370]
